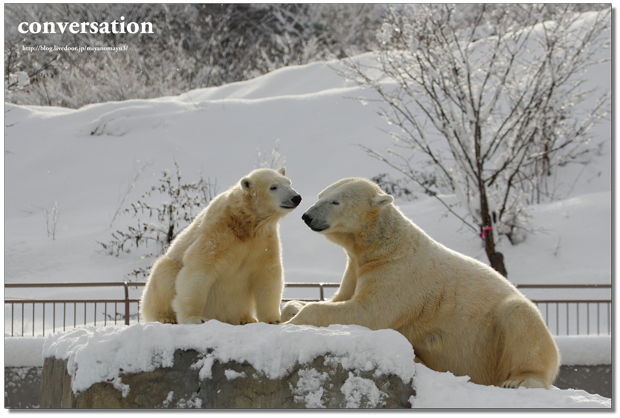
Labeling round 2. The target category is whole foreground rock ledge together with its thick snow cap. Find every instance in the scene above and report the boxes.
[41,321,414,408]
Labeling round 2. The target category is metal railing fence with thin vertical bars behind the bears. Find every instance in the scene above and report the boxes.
[4,282,613,336]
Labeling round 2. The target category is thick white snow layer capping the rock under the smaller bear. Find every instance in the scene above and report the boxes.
[42,320,414,392]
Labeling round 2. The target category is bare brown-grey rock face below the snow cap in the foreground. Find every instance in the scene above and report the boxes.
[40,350,414,408]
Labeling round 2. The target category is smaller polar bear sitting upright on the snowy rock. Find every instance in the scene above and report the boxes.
[140,168,301,325]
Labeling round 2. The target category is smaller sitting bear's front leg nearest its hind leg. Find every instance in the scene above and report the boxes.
[172,265,215,324]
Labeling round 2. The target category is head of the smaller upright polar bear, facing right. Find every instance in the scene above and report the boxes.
[240,167,301,214]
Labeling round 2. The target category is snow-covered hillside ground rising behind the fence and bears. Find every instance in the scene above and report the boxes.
[4,9,615,404]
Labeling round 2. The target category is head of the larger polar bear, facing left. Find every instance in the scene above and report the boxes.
[301,178,394,234]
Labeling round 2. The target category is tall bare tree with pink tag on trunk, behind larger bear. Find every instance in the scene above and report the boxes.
[350,4,611,276]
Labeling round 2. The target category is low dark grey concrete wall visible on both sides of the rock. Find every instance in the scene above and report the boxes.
[4,366,612,408]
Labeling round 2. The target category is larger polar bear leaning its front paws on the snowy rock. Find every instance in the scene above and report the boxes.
[282,178,559,389]
